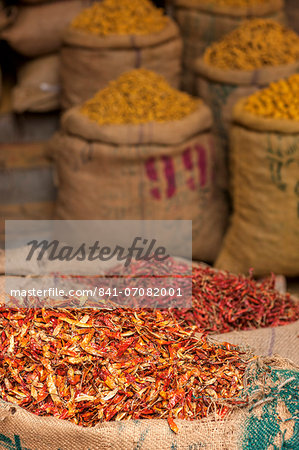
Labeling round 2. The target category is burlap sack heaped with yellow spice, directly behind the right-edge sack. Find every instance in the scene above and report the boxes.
[195,19,299,172]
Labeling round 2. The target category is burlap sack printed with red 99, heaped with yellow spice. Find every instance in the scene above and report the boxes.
[50,69,227,261]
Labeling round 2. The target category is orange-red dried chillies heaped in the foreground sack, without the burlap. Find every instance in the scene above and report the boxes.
[0,307,251,432]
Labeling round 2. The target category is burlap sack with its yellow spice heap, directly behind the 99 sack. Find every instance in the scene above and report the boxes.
[61,0,182,108]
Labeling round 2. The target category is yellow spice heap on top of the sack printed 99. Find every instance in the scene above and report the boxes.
[81,69,201,125]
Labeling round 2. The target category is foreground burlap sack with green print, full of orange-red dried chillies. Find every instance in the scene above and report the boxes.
[0,307,299,450]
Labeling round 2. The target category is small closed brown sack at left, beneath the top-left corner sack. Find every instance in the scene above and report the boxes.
[12,54,60,113]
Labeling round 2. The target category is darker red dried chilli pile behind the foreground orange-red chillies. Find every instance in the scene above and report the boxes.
[80,258,299,334]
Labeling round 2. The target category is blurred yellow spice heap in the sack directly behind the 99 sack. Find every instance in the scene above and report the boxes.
[71,0,168,36]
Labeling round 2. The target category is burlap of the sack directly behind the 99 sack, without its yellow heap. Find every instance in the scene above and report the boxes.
[61,18,182,108]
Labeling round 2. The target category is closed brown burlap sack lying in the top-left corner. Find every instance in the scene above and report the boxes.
[0,0,89,57]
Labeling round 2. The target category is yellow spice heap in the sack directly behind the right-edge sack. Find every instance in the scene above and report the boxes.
[204,19,299,70]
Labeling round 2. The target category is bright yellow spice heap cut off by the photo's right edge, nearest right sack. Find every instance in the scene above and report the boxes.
[245,74,299,121]
